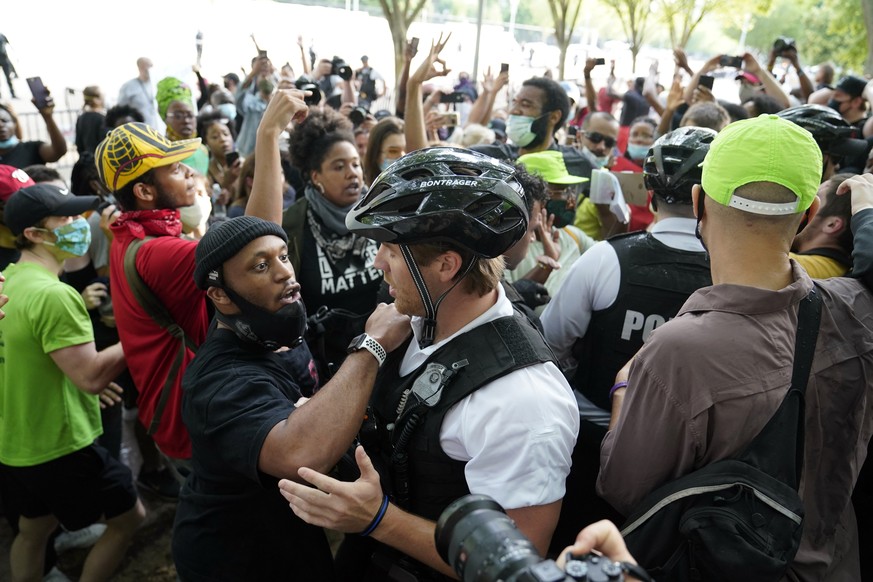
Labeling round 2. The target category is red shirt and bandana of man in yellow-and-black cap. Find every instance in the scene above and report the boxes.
[109,210,209,459]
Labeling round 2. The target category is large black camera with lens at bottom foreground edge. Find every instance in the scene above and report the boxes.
[434,495,638,582]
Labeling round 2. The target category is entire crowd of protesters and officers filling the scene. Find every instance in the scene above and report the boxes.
[0,26,873,582]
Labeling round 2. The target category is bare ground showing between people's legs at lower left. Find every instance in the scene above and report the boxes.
[0,420,176,582]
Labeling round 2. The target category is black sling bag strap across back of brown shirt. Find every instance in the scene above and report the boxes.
[737,284,822,490]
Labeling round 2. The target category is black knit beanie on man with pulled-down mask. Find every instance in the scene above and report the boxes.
[194,216,288,289]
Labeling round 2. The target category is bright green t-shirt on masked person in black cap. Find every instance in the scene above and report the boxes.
[0,263,103,467]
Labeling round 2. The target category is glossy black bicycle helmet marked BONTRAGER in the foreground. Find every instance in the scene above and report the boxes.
[346,147,529,258]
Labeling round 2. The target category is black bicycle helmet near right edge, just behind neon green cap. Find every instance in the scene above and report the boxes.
[776,105,867,157]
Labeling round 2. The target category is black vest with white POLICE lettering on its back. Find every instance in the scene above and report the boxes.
[571,232,712,410]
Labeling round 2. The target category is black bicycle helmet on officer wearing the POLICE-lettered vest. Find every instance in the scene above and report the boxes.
[643,126,718,204]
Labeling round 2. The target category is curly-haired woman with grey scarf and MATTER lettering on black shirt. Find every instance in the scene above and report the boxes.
[282,108,382,379]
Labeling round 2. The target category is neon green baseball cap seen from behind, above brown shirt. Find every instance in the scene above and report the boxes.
[700,115,822,215]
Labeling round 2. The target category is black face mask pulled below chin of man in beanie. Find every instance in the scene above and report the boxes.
[215,287,306,351]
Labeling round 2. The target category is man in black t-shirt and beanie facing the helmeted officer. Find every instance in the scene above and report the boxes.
[173,216,409,582]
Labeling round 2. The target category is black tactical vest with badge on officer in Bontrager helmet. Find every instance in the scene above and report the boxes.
[361,311,555,521]
